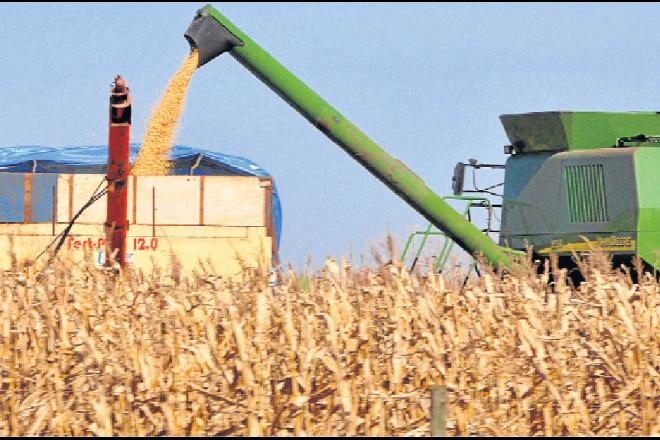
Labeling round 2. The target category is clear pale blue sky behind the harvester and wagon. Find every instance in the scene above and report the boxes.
[0,3,660,266]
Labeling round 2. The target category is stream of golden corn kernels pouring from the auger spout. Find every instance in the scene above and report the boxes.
[131,51,198,176]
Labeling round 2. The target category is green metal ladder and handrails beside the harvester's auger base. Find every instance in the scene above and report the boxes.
[401,196,493,276]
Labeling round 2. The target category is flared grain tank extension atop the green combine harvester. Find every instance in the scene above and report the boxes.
[500,111,660,153]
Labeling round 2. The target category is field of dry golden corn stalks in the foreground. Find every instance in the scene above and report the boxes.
[0,248,660,436]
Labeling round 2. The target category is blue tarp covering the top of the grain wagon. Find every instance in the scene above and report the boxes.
[0,144,282,248]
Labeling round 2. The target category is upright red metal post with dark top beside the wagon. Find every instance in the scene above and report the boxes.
[105,75,131,267]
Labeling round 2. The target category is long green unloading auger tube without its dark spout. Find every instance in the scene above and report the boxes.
[200,5,511,267]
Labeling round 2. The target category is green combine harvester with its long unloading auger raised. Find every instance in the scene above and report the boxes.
[184,5,660,276]
